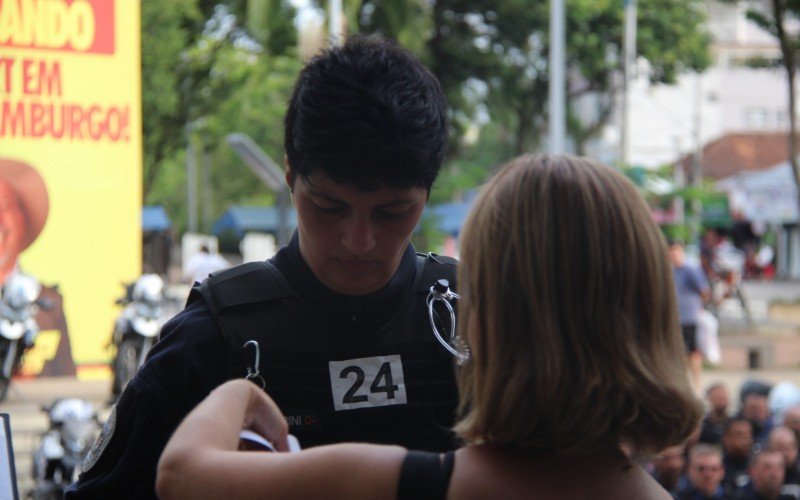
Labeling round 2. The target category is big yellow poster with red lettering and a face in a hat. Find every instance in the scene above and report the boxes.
[0,0,142,377]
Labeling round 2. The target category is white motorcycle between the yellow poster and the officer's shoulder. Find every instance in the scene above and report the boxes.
[111,274,168,400]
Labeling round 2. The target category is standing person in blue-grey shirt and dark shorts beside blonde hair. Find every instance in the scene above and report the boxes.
[669,241,711,391]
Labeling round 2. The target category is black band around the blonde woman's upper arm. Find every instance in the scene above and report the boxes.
[397,450,455,500]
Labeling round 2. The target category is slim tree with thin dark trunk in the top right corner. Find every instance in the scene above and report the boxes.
[747,0,800,218]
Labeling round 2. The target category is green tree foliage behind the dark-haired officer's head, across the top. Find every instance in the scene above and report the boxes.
[142,0,708,238]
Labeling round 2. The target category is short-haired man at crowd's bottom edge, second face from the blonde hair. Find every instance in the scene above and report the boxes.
[673,443,732,500]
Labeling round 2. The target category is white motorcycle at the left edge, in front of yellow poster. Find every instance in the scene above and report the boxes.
[0,273,52,401]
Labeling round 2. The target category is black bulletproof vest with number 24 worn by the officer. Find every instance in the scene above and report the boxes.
[190,254,457,451]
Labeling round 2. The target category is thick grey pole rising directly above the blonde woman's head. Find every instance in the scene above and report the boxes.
[548,0,566,154]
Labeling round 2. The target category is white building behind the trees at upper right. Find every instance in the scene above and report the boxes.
[587,1,788,167]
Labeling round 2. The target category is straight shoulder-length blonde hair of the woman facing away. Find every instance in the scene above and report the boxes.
[456,155,702,454]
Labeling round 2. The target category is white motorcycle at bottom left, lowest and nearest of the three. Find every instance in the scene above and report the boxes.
[30,398,100,500]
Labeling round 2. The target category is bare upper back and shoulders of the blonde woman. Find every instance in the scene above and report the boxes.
[448,447,672,500]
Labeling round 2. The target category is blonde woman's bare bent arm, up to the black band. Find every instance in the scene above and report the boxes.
[156,380,405,499]
